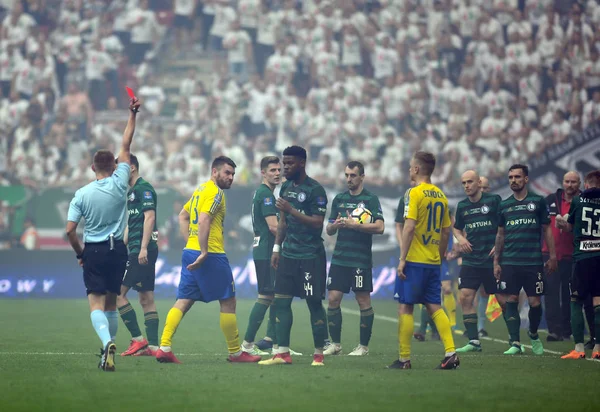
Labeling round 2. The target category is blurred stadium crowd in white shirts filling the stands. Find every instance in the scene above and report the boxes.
[0,0,600,247]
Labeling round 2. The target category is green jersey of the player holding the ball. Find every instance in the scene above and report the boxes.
[329,189,383,269]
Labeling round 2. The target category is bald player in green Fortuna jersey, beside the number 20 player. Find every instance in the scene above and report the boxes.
[453,170,503,353]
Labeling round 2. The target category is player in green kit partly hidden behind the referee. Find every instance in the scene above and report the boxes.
[117,155,158,356]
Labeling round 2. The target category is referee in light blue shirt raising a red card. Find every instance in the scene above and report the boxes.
[66,99,140,371]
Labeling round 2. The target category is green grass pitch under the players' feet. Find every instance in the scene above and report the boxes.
[0,300,600,412]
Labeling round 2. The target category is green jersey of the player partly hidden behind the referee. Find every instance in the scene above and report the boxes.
[127,177,158,253]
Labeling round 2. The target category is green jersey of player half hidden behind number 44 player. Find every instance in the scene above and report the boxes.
[252,183,279,260]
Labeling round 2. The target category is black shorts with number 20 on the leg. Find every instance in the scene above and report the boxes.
[497,265,545,296]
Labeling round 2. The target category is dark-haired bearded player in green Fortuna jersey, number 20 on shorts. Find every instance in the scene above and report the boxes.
[494,164,558,355]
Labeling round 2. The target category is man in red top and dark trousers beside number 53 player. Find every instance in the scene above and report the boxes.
[543,171,594,342]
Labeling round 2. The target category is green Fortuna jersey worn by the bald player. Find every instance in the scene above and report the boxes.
[454,193,502,268]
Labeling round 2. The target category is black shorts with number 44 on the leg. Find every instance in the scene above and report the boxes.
[275,254,327,300]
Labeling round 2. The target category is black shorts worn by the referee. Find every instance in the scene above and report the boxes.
[83,240,127,295]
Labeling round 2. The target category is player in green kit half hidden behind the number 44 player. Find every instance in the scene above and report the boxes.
[242,156,301,356]
